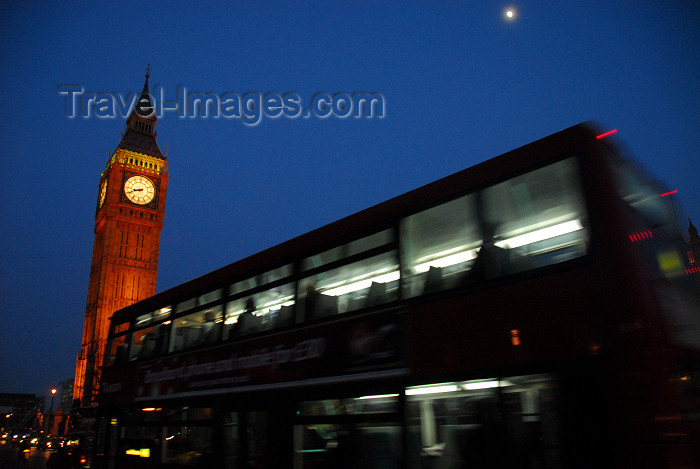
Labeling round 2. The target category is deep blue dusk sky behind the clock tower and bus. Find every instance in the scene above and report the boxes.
[0,0,700,395]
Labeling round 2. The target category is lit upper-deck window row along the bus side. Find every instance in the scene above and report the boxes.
[105,157,589,365]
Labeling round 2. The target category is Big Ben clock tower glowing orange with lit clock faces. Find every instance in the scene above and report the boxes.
[73,67,169,407]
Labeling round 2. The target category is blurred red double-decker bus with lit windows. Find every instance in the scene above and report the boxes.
[95,125,700,469]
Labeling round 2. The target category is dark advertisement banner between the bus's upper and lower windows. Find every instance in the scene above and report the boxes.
[101,313,406,405]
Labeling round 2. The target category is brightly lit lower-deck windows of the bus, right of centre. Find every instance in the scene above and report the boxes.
[294,375,561,469]
